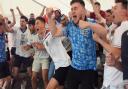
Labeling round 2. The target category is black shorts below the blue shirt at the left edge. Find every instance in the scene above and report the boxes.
[0,62,11,79]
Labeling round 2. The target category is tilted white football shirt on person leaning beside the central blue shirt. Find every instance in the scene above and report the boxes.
[43,32,71,69]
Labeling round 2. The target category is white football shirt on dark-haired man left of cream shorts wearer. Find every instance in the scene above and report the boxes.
[13,28,31,57]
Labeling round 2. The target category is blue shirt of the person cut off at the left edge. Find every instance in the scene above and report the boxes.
[0,33,6,62]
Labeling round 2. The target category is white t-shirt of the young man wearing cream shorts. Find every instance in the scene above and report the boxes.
[28,34,49,59]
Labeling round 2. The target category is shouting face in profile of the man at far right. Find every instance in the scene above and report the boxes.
[113,3,127,24]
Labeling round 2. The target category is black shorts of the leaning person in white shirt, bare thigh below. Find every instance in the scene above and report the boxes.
[53,67,69,85]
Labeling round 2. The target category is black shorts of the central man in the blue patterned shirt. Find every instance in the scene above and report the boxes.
[64,67,97,89]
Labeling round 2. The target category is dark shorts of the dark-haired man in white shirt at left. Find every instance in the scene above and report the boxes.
[13,55,32,68]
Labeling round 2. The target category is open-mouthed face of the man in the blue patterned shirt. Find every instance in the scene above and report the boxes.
[71,2,85,24]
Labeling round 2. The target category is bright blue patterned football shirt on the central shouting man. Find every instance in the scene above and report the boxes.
[64,20,96,70]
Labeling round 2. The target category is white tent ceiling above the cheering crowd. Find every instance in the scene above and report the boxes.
[0,0,114,16]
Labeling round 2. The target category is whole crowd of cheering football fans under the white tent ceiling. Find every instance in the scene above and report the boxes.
[0,0,128,89]
